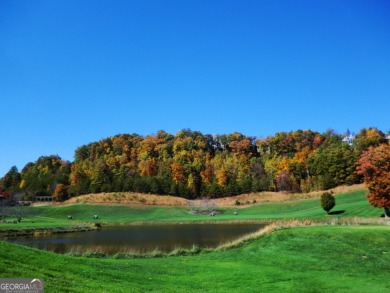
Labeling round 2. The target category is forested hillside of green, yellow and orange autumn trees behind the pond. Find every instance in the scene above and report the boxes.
[0,128,388,200]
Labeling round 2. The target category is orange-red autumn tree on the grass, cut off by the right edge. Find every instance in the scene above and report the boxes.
[357,144,390,217]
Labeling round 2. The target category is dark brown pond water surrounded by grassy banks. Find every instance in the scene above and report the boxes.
[8,223,264,254]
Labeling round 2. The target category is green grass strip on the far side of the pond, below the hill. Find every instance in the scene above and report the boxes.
[0,191,383,229]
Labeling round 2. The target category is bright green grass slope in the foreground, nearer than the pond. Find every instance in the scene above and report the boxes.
[0,226,390,293]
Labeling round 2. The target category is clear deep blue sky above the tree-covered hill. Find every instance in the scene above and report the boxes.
[0,0,390,176]
